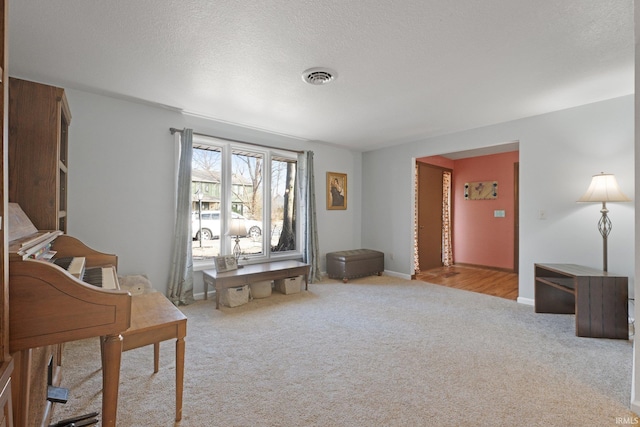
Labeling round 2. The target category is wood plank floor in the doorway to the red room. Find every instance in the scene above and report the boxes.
[416,266,518,300]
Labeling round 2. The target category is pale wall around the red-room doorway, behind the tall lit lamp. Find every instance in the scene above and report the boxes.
[362,96,635,300]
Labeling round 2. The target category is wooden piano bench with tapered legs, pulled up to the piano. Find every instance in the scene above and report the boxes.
[116,292,187,421]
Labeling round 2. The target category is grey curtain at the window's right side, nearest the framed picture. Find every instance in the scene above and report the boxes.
[298,151,322,283]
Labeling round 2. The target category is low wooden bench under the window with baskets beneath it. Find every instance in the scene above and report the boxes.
[202,261,310,309]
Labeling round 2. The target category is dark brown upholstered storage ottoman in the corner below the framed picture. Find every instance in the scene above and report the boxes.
[327,249,384,283]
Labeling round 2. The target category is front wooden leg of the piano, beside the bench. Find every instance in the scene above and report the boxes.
[102,335,122,427]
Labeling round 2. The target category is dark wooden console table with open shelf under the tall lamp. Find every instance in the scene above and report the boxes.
[534,264,629,339]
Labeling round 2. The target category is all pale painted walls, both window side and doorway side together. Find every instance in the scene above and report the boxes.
[61,90,634,298]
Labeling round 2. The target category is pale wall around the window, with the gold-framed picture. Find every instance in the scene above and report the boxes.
[66,89,362,294]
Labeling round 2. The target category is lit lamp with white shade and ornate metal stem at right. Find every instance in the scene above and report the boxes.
[578,172,631,271]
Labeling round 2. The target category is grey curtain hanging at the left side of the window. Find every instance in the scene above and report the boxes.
[168,129,194,305]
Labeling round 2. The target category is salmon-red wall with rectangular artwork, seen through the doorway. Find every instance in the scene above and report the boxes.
[452,151,519,270]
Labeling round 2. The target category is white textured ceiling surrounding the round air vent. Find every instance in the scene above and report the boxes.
[9,0,634,151]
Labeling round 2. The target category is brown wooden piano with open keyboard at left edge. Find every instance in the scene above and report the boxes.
[9,203,131,426]
